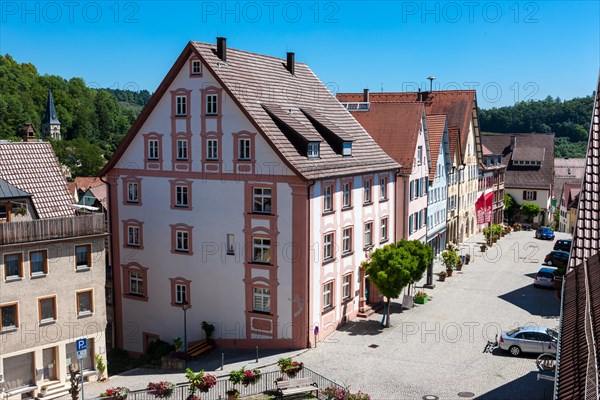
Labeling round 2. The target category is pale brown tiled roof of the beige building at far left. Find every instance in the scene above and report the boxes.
[0,142,74,218]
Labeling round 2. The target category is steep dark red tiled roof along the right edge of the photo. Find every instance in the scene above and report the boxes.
[555,75,600,399]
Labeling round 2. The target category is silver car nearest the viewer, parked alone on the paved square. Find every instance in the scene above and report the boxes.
[498,326,558,356]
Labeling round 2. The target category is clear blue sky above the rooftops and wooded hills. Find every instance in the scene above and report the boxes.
[0,0,600,108]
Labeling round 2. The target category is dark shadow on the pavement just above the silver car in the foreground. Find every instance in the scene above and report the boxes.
[498,285,560,317]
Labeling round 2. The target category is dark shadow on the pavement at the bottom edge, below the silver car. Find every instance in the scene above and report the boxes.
[476,371,554,400]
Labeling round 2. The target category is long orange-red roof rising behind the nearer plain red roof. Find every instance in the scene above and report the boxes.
[337,90,481,163]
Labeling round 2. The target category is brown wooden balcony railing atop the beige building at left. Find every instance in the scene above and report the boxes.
[0,213,106,246]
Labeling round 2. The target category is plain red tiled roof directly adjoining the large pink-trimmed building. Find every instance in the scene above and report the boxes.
[344,102,425,174]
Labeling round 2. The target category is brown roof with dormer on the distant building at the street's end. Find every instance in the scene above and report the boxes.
[481,133,554,190]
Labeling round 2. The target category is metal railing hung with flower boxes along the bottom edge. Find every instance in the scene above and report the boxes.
[90,367,344,400]
